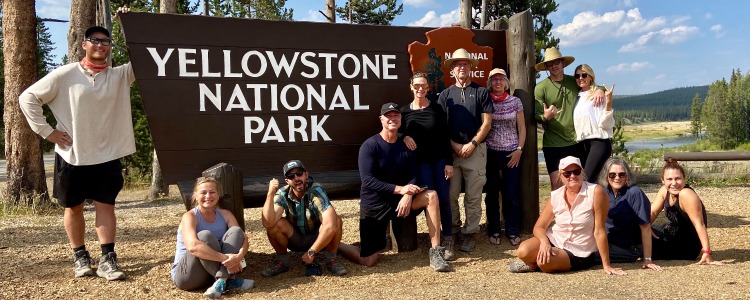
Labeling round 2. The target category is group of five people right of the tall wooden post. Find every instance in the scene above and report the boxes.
[509,48,720,275]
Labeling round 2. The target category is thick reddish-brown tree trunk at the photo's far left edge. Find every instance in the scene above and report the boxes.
[3,0,49,205]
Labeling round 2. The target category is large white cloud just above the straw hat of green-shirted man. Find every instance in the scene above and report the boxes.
[552,8,667,47]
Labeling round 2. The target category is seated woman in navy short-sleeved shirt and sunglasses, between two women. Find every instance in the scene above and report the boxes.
[599,157,661,271]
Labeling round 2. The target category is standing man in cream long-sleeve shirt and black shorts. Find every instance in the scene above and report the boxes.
[19,26,135,280]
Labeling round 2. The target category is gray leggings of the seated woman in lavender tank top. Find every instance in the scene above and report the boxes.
[172,226,245,290]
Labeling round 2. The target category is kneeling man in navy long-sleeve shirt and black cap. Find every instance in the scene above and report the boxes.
[339,103,451,272]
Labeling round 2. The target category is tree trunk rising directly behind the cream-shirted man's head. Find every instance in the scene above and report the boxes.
[68,0,96,62]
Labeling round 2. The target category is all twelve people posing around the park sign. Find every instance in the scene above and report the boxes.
[19,14,724,298]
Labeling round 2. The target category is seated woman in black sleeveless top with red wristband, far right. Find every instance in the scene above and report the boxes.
[651,157,721,265]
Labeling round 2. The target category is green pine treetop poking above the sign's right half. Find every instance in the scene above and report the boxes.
[336,0,404,25]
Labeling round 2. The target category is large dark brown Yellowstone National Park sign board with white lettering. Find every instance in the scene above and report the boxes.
[121,13,507,183]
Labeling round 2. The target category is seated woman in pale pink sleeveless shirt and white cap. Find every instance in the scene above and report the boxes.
[508,156,625,275]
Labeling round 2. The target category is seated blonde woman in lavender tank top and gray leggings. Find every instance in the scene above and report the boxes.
[171,177,254,298]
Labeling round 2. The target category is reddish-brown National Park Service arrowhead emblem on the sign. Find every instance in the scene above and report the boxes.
[409,27,493,98]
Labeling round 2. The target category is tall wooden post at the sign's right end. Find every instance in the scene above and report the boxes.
[506,10,539,233]
